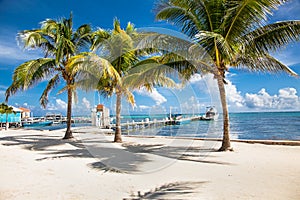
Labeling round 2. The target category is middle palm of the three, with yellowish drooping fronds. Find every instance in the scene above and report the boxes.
[70,19,184,142]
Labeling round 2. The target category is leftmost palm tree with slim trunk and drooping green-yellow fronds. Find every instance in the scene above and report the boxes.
[6,13,91,139]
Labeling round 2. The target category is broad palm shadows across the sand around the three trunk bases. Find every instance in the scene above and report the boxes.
[0,128,231,173]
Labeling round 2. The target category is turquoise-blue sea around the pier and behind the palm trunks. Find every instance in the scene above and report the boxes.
[24,112,300,140]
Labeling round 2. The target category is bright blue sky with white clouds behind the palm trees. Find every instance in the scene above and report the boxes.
[0,0,300,115]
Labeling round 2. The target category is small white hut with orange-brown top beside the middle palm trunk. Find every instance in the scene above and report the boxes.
[91,104,110,128]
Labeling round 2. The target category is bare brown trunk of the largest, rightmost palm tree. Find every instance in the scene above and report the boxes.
[217,74,232,151]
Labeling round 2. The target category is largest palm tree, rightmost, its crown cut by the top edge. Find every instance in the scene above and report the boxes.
[155,0,300,151]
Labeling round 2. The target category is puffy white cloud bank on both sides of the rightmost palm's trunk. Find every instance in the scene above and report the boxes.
[192,74,300,111]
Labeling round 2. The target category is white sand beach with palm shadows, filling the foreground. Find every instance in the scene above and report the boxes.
[0,128,300,200]
